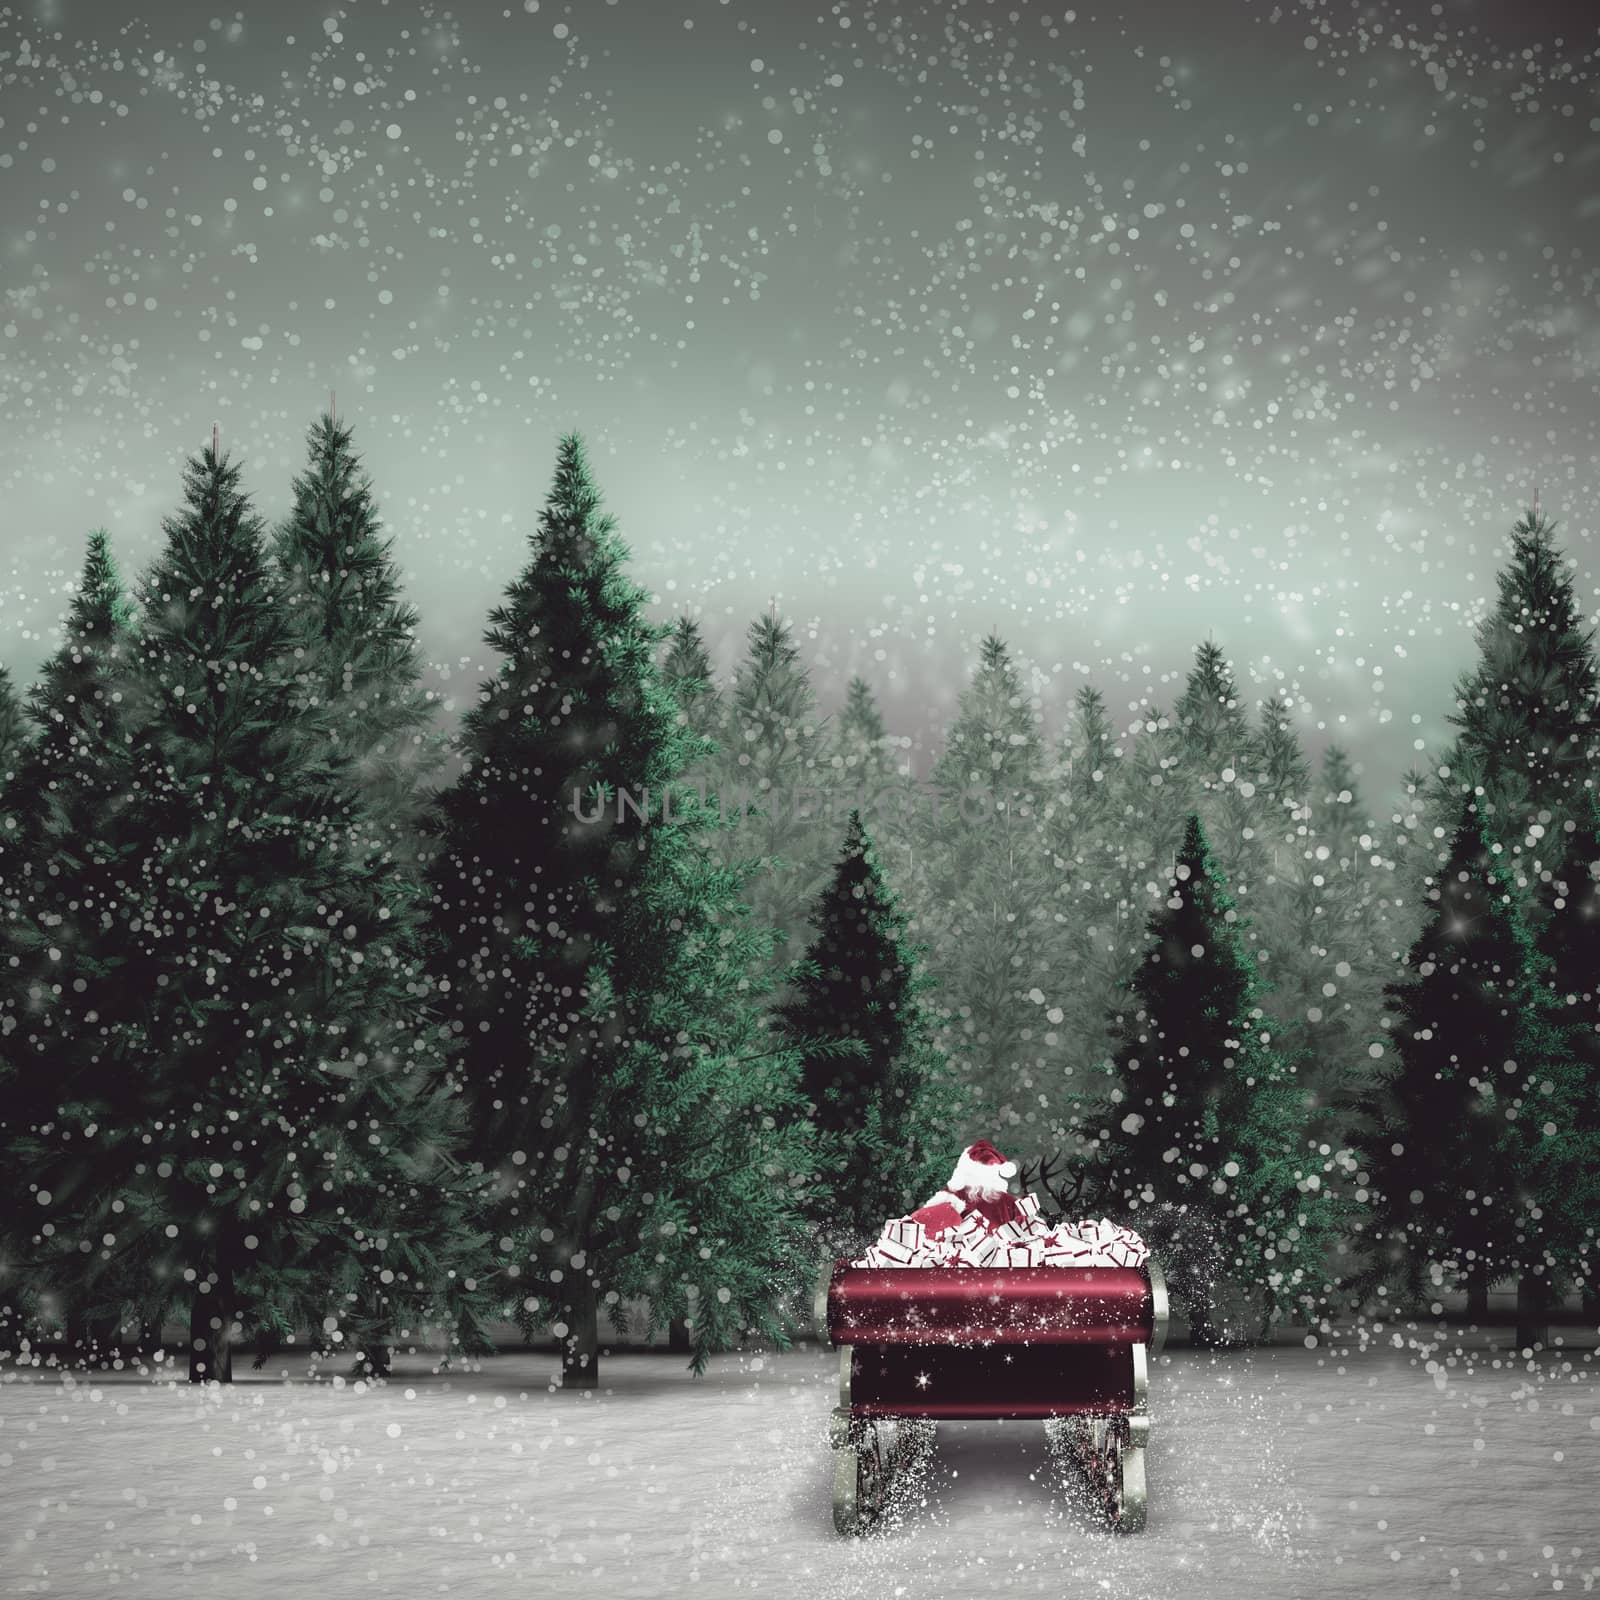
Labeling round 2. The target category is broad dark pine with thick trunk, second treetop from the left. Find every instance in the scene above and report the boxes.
[11,450,486,1381]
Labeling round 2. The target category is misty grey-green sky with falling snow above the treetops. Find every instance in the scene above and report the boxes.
[0,0,1600,800]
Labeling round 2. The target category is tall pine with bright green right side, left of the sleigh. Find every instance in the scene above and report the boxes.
[429,435,813,1387]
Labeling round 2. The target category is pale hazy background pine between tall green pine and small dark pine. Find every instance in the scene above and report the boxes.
[712,614,834,960]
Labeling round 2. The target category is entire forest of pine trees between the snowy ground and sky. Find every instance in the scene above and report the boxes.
[0,416,1600,1386]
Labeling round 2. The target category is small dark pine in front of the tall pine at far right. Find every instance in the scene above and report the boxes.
[1366,798,1568,1318]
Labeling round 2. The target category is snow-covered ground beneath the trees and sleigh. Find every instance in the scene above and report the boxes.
[0,1334,1600,1600]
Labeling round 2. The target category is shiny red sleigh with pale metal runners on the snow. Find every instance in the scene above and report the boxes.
[816,1256,1166,1533]
